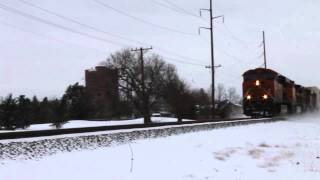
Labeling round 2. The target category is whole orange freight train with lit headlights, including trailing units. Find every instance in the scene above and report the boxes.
[242,68,320,117]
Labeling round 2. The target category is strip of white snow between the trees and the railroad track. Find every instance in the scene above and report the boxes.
[0,117,190,133]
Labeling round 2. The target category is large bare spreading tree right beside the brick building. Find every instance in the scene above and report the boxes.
[105,49,177,123]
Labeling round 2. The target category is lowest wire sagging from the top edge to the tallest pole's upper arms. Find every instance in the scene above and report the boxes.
[92,0,197,36]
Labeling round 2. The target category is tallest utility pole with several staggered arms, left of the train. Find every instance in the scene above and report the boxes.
[199,0,224,119]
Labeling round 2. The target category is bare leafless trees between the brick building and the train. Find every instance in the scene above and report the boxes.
[102,49,239,123]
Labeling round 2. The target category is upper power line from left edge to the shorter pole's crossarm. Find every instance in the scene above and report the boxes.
[0,3,127,47]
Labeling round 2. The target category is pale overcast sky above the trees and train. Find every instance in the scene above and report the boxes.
[0,0,320,97]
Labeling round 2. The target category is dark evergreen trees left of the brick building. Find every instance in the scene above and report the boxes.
[0,83,90,129]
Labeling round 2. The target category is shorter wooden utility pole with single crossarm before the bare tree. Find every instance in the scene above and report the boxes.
[131,47,152,124]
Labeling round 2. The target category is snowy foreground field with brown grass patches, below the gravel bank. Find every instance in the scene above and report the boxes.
[0,115,320,180]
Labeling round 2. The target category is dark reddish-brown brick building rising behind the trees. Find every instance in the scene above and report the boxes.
[85,66,119,118]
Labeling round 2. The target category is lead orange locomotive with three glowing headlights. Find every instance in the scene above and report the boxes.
[242,68,282,116]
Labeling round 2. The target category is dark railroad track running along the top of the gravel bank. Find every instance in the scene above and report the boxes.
[0,117,284,140]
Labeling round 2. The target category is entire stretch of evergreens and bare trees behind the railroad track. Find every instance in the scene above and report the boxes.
[0,49,239,129]
